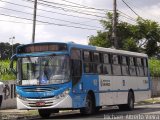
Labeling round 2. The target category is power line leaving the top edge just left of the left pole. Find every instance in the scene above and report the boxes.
[23,0,105,18]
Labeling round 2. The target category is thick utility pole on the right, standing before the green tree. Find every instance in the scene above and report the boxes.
[112,0,118,48]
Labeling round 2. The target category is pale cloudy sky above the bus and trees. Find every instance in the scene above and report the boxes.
[0,0,160,44]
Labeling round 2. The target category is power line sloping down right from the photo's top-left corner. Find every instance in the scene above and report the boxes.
[0,0,100,21]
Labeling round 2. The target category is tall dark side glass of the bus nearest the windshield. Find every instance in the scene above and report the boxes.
[71,49,82,86]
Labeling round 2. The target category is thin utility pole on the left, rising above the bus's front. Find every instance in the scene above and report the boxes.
[32,0,37,43]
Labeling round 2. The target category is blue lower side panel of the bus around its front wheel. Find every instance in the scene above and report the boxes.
[72,74,99,108]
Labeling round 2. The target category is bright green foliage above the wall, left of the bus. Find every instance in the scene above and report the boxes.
[0,60,16,80]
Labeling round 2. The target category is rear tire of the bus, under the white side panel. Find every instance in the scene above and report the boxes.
[118,91,134,111]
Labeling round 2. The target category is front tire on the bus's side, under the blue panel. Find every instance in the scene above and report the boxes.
[80,94,95,115]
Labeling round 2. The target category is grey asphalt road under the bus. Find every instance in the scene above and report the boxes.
[0,104,160,120]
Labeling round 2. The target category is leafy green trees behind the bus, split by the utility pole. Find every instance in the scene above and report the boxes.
[89,13,160,56]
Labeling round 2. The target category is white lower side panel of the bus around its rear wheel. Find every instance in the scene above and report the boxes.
[99,75,150,105]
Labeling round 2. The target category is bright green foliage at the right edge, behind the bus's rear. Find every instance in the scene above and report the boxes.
[149,58,160,77]
